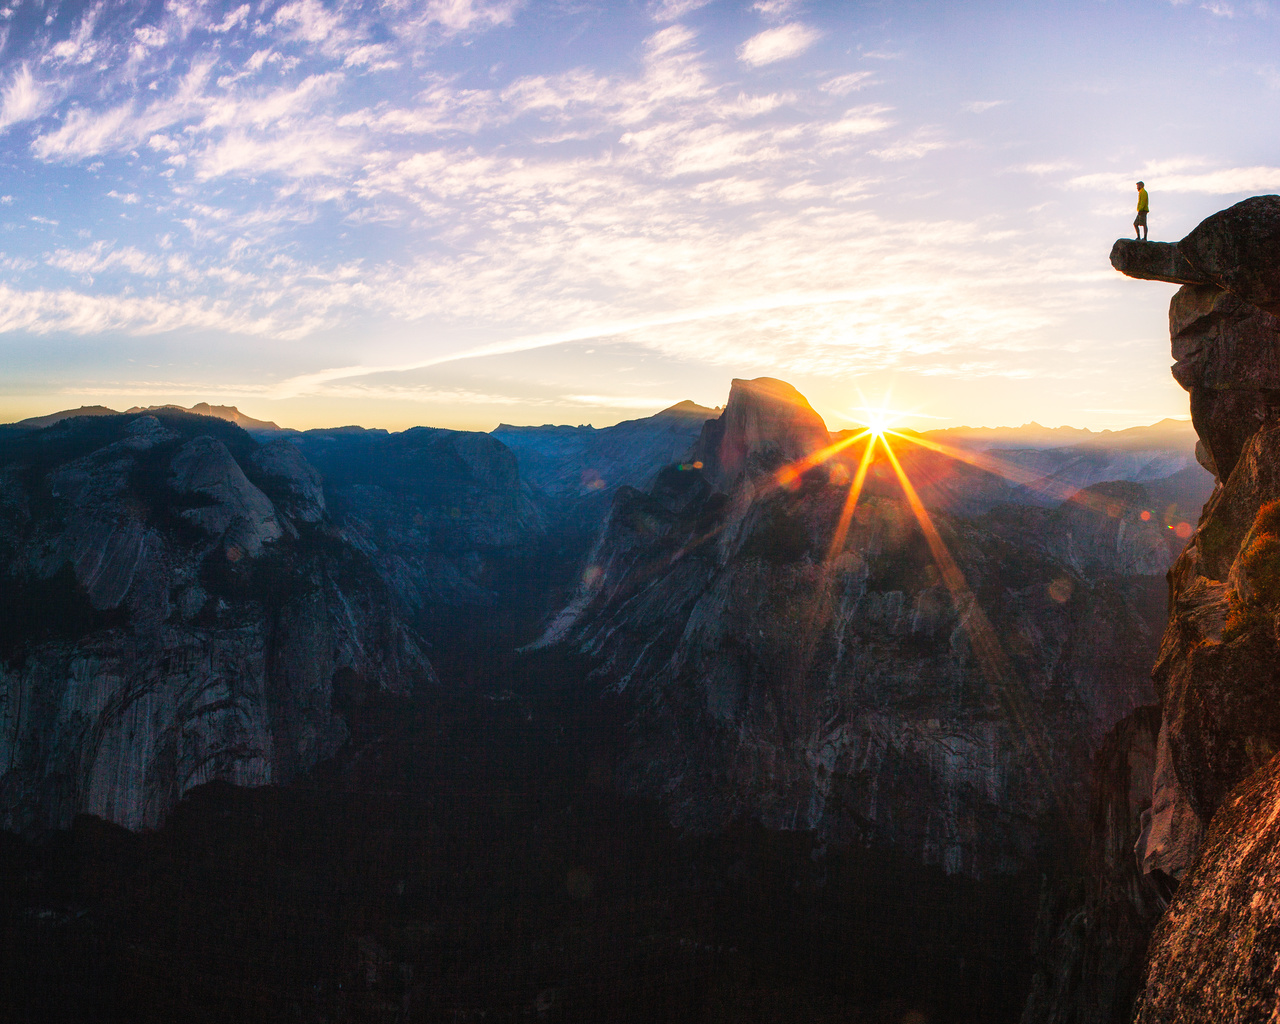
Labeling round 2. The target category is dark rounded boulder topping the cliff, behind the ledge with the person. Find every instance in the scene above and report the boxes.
[1178,196,1280,314]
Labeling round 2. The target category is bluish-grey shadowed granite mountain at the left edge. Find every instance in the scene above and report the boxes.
[0,413,433,829]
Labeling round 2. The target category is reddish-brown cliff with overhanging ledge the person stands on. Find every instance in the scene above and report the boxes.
[1112,196,1280,1024]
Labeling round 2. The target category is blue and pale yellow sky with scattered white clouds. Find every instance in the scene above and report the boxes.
[0,0,1280,430]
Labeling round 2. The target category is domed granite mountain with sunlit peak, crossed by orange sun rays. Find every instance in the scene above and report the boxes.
[544,381,1167,876]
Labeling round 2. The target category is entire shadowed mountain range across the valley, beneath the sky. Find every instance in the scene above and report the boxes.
[0,379,1213,1019]
